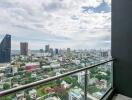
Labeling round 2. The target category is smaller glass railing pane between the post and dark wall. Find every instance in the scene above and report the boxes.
[87,62,112,99]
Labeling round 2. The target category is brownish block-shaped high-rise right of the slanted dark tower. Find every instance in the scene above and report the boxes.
[20,42,28,56]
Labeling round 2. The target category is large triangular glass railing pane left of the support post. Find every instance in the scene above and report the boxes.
[0,72,85,100]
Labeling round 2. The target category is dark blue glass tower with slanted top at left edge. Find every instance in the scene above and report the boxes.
[0,34,11,63]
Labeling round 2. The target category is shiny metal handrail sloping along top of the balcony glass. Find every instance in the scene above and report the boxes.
[0,59,115,97]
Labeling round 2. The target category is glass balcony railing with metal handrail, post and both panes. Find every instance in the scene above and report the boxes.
[0,59,113,100]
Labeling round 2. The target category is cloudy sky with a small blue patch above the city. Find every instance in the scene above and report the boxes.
[0,0,111,50]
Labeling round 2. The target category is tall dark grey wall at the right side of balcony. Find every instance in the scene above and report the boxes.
[112,0,132,97]
